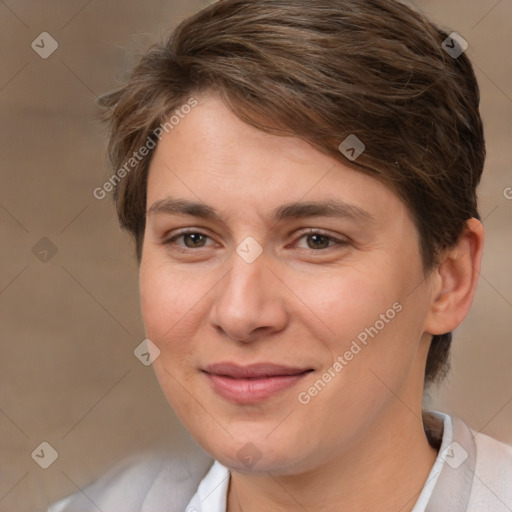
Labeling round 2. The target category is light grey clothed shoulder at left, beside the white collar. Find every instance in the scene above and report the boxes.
[48,450,213,512]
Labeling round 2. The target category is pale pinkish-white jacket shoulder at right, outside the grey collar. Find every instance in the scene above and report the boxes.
[468,430,512,512]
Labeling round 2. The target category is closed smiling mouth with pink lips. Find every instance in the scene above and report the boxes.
[202,363,314,404]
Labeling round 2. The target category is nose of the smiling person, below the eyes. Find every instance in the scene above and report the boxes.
[210,245,288,343]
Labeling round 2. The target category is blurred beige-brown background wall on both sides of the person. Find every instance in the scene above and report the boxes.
[0,0,512,512]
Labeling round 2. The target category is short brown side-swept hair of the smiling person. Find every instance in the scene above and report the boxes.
[100,0,485,384]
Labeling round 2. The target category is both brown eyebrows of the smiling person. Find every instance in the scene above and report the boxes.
[147,197,376,224]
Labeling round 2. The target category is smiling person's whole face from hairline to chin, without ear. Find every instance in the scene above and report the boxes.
[140,91,431,474]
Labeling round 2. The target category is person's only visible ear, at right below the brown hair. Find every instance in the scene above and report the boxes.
[425,218,484,334]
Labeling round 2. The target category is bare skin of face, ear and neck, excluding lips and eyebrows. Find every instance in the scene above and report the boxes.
[140,94,483,512]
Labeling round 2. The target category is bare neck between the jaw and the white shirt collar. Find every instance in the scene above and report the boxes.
[227,403,437,512]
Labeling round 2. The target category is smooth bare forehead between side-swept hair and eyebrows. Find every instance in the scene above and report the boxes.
[147,94,404,225]
